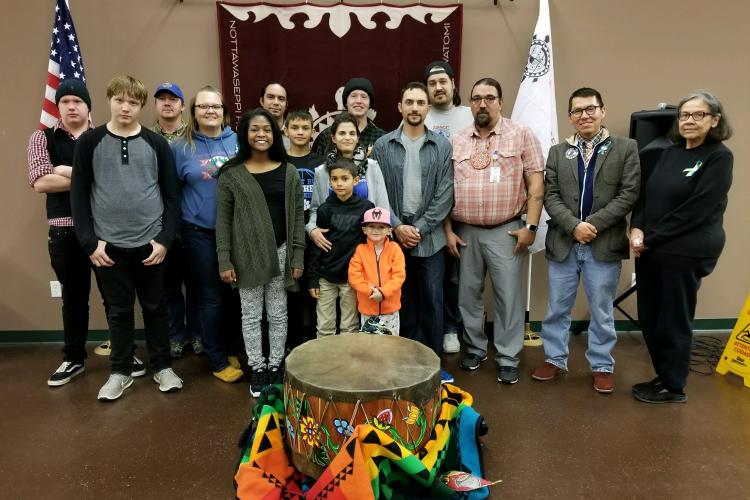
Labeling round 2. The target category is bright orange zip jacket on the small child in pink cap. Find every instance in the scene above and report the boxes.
[349,240,406,316]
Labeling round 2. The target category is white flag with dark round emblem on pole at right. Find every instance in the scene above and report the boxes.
[510,0,557,253]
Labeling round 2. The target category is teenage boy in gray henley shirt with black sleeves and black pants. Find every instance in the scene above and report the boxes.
[71,76,182,401]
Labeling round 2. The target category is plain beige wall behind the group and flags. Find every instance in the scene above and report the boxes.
[0,0,750,331]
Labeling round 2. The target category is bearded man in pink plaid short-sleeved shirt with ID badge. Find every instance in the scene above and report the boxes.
[446,78,544,384]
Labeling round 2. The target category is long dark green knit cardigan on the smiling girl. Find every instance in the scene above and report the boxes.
[216,163,305,290]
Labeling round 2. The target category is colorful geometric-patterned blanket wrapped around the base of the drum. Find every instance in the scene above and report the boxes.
[235,384,487,500]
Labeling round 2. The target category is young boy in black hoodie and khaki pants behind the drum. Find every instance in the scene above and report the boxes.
[308,158,375,337]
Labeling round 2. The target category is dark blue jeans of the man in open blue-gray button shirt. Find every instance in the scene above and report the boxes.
[401,250,445,356]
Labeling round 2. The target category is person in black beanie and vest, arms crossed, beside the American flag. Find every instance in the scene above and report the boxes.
[27,78,145,387]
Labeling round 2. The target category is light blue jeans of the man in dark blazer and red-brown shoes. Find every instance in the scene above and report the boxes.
[542,243,622,373]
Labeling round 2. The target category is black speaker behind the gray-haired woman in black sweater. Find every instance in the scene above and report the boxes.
[630,106,677,171]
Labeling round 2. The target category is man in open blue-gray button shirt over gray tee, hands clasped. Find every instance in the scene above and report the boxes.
[372,82,453,382]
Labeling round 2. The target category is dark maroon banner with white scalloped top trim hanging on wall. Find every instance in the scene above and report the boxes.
[216,2,463,133]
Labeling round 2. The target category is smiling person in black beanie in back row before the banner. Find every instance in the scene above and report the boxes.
[312,78,385,157]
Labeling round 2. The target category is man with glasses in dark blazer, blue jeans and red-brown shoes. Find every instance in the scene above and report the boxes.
[531,87,641,394]
